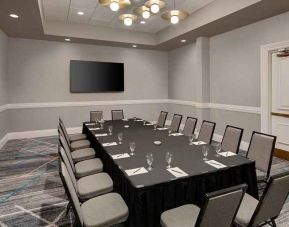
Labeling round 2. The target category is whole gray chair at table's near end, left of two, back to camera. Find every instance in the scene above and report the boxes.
[161,185,246,227]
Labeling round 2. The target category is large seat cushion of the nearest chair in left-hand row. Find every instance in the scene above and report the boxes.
[81,193,128,227]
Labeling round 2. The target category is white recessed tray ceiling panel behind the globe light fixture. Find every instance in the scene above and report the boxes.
[42,0,214,33]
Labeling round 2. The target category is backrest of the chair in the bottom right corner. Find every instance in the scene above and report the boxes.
[249,172,289,226]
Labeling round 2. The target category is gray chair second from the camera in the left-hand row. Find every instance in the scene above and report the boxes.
[60,148,113,201]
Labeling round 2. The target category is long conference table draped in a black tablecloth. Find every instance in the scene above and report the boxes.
[83,118,258,227]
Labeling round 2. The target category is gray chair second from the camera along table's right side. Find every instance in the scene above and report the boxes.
[221,125,244,154]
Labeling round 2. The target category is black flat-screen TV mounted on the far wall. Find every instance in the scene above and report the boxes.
[70,60,124,93]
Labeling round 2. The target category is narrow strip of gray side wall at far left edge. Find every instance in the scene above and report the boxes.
[0,29,9,139]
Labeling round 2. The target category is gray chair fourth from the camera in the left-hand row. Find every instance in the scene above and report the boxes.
[58,127,95,163]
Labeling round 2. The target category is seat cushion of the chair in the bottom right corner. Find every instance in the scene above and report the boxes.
[235,193,258,226]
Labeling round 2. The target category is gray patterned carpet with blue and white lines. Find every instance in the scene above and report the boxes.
[0,137,289,227]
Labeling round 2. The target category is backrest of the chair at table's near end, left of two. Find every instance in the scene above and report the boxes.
[195,184,247,227]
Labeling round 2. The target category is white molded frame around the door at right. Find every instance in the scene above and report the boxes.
[260,40,289,133]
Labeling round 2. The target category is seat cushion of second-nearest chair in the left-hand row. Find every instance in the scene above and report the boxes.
[77,173,113,201]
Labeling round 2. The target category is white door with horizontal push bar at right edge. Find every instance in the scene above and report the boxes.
[271,53,289,151]
